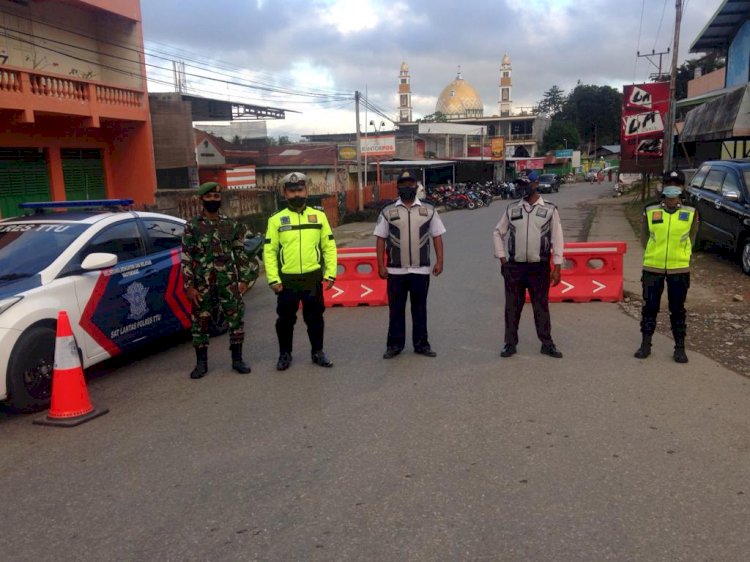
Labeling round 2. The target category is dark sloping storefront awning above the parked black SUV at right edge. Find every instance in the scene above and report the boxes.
[680,84,750,142]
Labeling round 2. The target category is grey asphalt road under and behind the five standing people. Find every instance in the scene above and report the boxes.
[0,185,750,561]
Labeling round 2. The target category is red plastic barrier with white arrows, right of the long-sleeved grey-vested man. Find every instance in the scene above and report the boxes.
[526,242,627,302]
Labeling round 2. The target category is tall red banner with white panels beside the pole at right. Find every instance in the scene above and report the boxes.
[620,82,669,174]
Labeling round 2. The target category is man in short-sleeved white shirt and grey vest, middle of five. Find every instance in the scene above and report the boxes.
[374,170,445,359]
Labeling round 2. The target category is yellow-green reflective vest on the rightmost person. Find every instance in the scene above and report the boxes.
[643,205,695,271]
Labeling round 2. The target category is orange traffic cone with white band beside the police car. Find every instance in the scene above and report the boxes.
[34,310,109,427]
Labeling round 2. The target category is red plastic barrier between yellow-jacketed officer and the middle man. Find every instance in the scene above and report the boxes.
[323,247,388,307]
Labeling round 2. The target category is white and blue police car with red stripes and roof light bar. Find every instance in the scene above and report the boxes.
[0,199,190,411]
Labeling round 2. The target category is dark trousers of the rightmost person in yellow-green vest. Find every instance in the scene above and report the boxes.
[641,271,690,339]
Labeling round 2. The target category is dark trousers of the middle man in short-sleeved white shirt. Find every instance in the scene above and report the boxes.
[386,273,430,350]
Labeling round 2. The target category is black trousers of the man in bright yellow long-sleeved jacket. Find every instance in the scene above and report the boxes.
[276,270,325,354]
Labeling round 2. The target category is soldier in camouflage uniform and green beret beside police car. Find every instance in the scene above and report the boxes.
[182,182,253,379]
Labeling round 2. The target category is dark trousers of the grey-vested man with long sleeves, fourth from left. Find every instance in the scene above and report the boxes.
[502,261,552,345]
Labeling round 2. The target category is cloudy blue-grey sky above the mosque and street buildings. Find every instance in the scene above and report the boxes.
[141,0,723,140]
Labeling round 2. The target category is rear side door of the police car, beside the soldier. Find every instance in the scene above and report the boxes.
[141,217,191,335]
